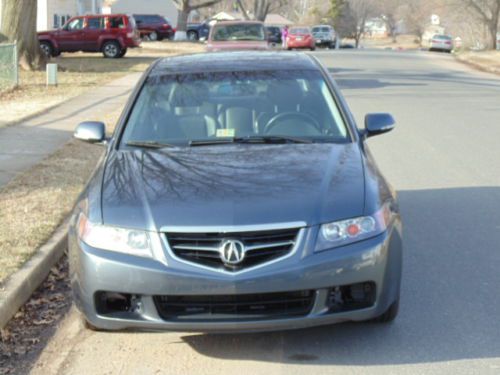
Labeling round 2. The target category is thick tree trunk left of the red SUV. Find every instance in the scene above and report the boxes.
[2,0,45,70]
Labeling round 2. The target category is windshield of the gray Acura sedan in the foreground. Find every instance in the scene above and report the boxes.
[121,71,350,146]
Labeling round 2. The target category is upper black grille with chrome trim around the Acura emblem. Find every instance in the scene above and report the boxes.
[166,228,299,271]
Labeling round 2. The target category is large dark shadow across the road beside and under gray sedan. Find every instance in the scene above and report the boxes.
[183,187,500,366]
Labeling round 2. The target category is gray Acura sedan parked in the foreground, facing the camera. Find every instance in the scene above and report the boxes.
[69,52,402,332]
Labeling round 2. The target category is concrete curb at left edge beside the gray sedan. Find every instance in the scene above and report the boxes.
[0,220,68,328]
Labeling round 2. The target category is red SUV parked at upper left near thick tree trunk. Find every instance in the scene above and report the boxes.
[38,14,141,58]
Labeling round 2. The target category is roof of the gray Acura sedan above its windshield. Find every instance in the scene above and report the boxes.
[150,51,318,76]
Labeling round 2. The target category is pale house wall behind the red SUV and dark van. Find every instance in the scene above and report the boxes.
[102,0,179,26]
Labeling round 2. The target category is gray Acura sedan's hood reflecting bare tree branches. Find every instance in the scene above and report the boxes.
[102,144,364,230]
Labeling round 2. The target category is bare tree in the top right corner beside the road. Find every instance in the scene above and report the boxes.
[455,0,500,49]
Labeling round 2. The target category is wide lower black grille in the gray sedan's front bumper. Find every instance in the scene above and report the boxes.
[153,290,314,321]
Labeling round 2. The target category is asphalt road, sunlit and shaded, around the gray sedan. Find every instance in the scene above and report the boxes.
[30,51,500,375]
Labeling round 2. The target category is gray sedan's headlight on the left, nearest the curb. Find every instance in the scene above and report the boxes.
[78,214,152,257]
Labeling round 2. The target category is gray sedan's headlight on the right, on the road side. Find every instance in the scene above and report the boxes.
[315,205,391,251]
